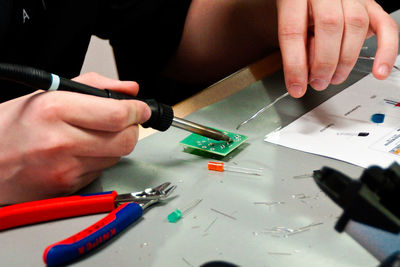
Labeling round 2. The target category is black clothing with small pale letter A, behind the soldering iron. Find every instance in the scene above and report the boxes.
[0,0,191,102]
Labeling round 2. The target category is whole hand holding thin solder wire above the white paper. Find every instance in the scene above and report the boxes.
[277,0,399,97]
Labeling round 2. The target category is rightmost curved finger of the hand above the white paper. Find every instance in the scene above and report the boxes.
[367,1,399,79]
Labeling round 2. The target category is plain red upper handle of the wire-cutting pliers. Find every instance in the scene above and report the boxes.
[0,191,118,230]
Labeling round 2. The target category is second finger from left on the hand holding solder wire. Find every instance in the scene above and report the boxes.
[309,0,344,90]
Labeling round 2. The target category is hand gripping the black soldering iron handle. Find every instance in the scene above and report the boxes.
[0,73,151,205]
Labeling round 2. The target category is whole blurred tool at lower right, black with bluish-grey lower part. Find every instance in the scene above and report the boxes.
[313,162,400,267]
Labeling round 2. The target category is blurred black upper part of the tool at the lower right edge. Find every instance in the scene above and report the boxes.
[314,163,400,233]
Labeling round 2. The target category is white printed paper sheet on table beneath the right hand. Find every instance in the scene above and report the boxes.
[265,58,400,168]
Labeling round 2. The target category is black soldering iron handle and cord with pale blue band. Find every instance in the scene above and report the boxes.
[0,63,174,131]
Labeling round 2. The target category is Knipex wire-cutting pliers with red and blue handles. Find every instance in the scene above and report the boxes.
[0,182,176,266]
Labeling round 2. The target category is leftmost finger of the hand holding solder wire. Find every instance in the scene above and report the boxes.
[277,0,308,97]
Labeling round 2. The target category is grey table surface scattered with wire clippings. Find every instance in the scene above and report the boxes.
[0,9,400,266]
